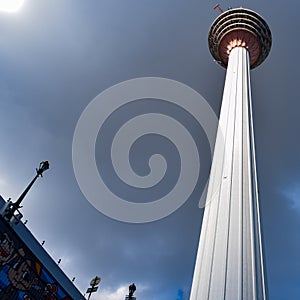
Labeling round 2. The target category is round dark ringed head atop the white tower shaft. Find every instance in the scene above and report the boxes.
[208,8,272,69]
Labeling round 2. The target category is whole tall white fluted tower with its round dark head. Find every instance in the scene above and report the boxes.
[190,8,272,300]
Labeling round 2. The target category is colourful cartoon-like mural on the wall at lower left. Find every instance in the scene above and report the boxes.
[0,216,72,300]
